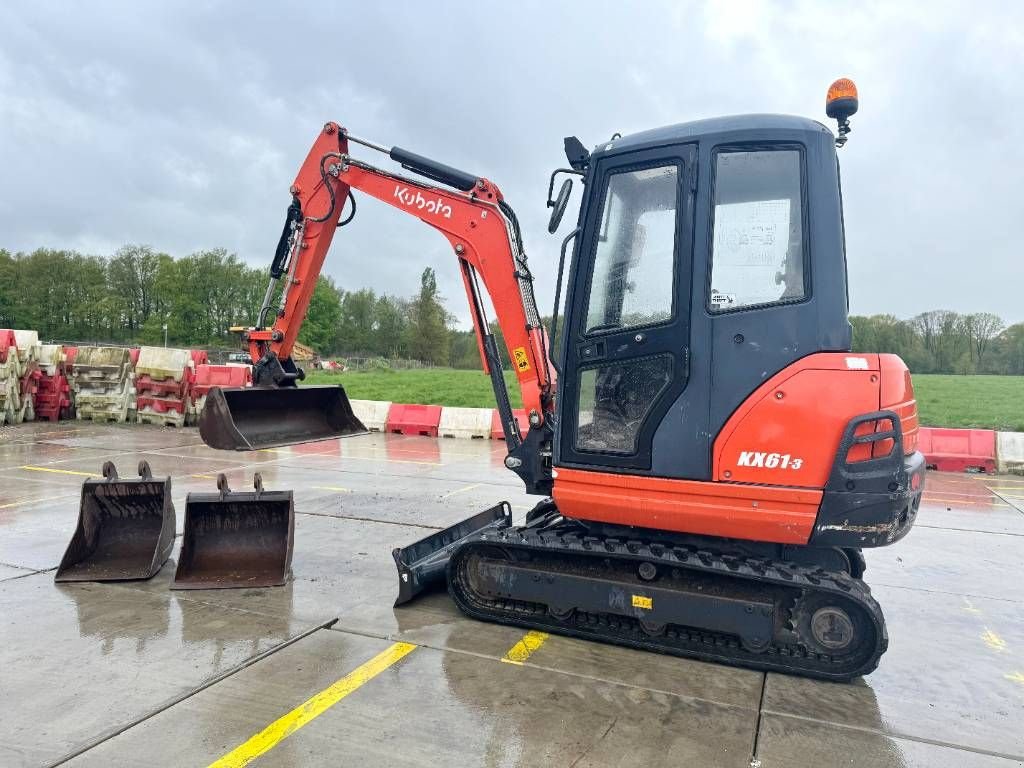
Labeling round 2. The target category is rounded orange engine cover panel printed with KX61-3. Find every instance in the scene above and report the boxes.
[712,352,881,488]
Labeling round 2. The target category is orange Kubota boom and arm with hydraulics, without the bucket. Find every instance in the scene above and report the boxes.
[214,123,555,489]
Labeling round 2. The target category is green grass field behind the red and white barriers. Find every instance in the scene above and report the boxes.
[306,368,1024,432]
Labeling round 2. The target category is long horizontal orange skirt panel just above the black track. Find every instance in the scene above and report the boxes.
[552,469,821,544]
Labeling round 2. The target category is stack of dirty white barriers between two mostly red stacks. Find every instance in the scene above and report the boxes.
[71,347,136,424]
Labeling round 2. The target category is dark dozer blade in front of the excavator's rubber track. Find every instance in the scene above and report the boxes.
[391,502,512,605]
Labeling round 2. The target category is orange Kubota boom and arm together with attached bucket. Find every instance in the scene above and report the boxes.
[200,123,555,487]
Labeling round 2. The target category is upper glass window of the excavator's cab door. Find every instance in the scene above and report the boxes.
[587,165,679,333]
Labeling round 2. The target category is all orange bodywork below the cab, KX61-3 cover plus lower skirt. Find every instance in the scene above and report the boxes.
[552,352,918,544]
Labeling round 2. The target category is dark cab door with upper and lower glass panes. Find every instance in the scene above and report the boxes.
[557,144,696,470]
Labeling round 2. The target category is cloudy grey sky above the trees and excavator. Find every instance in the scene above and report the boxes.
[0,0,1024,322]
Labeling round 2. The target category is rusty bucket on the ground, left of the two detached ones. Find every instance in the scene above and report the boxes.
[53,461,174,582]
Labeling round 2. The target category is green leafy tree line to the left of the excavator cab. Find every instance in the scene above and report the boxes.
[0,245,458,365]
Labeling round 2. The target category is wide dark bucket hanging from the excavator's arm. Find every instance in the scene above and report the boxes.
[199,386,369,451]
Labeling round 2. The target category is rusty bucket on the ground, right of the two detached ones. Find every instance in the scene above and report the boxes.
[171,472,295,590]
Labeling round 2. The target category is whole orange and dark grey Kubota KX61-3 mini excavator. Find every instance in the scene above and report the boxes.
[200,79,925,680]
